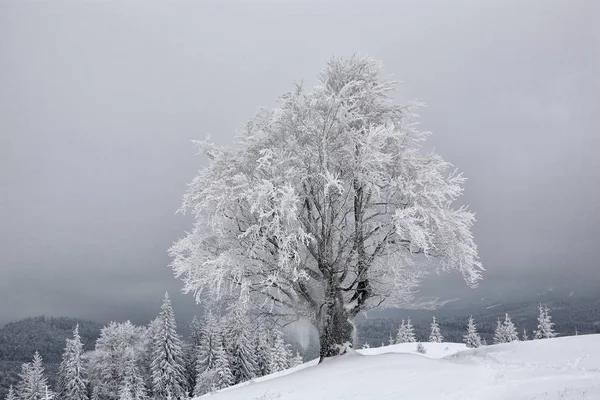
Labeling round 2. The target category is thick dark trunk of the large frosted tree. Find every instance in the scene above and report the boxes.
[319,285,354,362]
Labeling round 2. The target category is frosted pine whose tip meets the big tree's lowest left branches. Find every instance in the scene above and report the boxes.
[223,302,258,384]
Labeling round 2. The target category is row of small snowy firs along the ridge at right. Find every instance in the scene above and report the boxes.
[386,304,557,347]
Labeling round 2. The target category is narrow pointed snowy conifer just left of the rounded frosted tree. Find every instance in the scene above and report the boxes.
[56,325,88,400]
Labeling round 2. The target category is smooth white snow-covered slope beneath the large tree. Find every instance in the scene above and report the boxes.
[199,335,600,400]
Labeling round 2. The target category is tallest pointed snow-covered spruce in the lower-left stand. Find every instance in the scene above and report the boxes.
[151,293,187,399]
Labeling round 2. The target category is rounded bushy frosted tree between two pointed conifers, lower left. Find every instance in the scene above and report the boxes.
[88,321,147,400]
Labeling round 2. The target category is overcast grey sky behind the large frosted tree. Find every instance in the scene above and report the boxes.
[0,0,600,324]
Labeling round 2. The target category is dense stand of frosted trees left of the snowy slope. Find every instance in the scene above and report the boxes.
[6,294,302,400]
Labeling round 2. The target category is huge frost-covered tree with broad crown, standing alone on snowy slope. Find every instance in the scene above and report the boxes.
[169,57,483,359]
